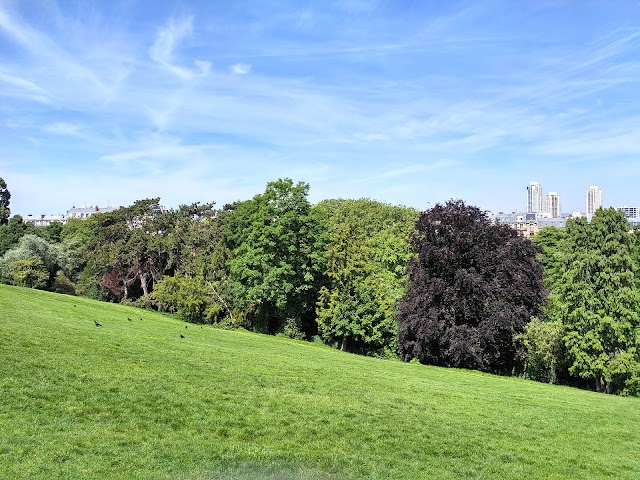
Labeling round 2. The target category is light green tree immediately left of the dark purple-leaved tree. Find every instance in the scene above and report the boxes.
[314,199,418,356]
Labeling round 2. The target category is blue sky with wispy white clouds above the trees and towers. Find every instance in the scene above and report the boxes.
[0,0,640,215]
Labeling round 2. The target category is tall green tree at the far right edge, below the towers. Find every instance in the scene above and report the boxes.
[555,208,640,393]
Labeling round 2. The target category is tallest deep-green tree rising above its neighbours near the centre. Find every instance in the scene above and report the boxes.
[223,179,324,335]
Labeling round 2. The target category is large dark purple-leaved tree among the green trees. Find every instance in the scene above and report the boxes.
[398,200,545,374]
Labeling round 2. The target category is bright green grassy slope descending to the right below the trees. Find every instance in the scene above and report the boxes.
[0,285,640,479]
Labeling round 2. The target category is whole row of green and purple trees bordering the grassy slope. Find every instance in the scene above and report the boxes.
[0,179,640,394]
